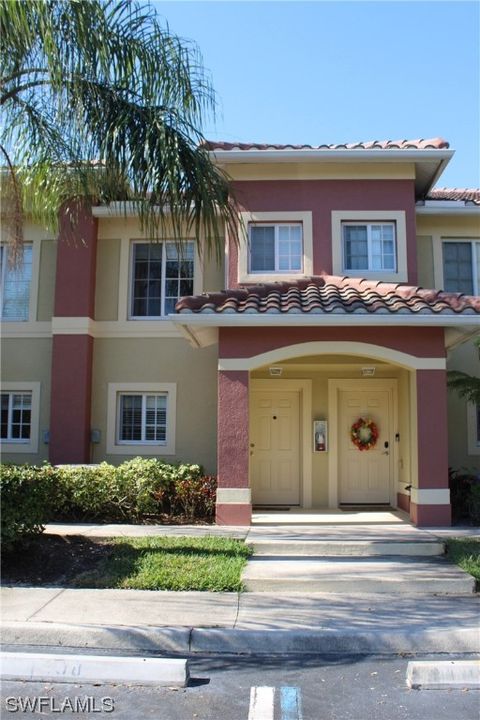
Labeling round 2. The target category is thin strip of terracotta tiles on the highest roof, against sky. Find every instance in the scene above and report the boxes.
[202,137,449,151]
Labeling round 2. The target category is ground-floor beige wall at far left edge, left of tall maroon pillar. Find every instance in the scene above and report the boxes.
[1,338,52,464]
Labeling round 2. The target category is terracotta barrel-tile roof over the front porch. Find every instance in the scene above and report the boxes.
[176,275,480,315]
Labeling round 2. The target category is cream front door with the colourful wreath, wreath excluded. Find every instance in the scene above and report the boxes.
[338,389,393,504]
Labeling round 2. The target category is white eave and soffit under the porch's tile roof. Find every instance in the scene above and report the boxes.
[168,313,480,348]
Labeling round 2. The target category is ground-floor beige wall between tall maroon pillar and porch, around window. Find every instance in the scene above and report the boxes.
[92,338,217,473]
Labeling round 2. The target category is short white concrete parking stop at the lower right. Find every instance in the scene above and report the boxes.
[407,660,480,690]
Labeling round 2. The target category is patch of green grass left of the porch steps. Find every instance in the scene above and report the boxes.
[73,537,251,592]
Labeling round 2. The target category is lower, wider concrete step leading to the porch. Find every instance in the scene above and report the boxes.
[242,556,475,592]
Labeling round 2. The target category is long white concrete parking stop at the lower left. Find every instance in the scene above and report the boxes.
[0,652,189,687]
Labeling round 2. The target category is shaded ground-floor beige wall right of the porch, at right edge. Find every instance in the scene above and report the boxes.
[447,333,480,473]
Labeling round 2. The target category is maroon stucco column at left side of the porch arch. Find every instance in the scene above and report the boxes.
[216,370,252,525]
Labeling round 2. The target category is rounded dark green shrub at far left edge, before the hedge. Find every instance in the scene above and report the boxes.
[0,465,57,549]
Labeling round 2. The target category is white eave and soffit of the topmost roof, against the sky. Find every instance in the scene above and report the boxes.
[209,148,455,197]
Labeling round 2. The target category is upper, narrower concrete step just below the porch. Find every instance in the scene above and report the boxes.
[247,538,445,557]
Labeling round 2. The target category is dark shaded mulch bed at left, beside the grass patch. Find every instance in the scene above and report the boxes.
[2,535,112,587]
